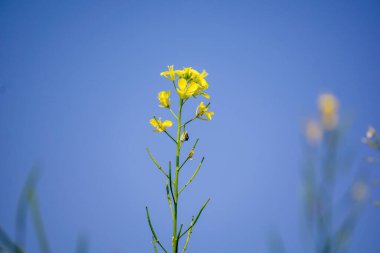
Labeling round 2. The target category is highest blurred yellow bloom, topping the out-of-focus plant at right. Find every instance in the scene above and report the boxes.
[318,93,339,130]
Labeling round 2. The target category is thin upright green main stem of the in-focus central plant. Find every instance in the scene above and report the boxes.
[172,98,183,253]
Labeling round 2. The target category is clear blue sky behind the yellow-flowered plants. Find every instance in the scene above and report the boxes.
[0,0,380,253]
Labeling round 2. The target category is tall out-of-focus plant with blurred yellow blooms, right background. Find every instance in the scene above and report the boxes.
[302,94,365,253]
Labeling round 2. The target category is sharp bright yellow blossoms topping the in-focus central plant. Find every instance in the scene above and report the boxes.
[150,65,214,132]
